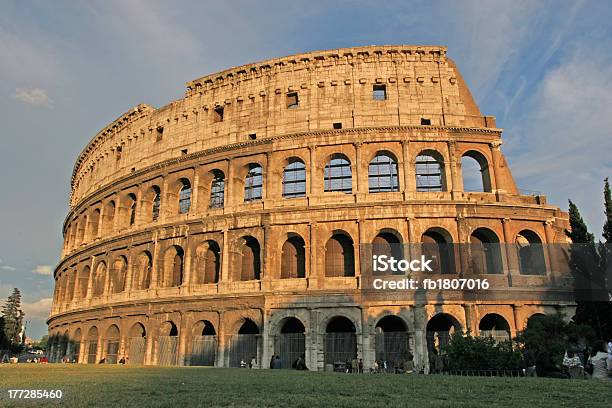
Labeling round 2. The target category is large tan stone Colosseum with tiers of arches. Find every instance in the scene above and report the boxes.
[48,45,575,371]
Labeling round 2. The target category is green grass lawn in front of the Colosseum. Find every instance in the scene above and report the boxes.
[0,364,612,408]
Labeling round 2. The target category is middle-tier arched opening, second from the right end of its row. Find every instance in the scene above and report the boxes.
[469,228,503,274]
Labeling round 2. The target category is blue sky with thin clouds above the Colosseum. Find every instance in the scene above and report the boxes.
[0,0,612,337]
